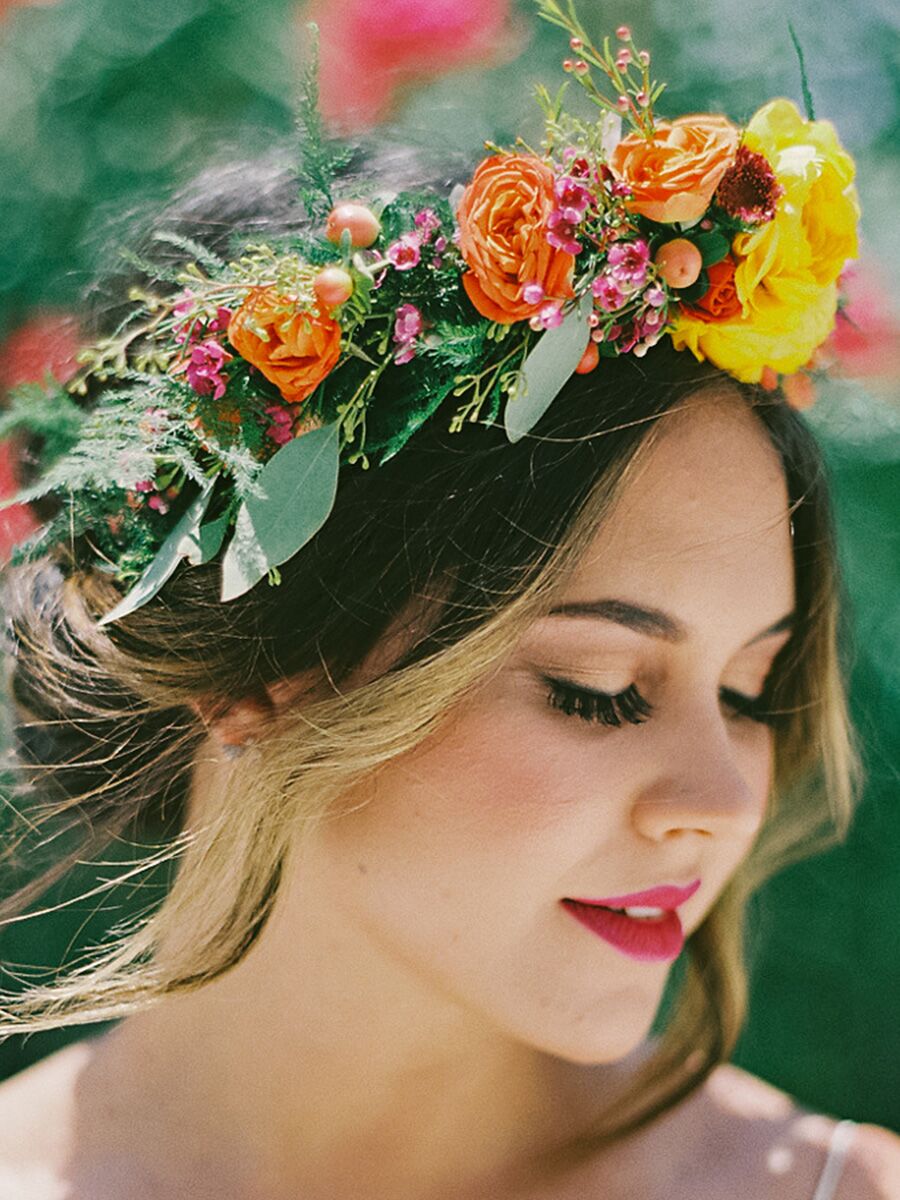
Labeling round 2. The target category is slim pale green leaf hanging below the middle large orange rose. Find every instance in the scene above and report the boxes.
[504,295,592,442]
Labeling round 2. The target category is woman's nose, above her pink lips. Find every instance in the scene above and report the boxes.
[631,724,769,841]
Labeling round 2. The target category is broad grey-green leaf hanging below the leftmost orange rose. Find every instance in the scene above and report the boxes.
[222,422,340,601]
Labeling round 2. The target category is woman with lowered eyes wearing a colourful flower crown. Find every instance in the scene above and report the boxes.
[0,14,900,1200]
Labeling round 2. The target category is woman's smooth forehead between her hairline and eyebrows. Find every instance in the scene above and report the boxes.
[562,392,793,636]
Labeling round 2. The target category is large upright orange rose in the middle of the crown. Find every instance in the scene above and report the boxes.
[456,154,575,325]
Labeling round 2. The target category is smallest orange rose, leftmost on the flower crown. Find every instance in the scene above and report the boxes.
[228,288,341,404]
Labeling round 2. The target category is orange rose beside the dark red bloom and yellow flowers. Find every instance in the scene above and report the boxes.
[610,113,738,224]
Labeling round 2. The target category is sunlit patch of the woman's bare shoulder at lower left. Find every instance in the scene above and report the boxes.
[0,1040,92,1200]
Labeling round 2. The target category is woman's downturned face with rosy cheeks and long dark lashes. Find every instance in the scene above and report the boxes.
[297,391,793,1062]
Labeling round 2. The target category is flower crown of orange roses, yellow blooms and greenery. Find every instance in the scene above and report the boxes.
[0,0,859,622]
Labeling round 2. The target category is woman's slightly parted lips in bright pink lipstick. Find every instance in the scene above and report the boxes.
[560,880,701,962]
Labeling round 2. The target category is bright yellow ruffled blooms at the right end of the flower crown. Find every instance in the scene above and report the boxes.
[672,100,859,383]
